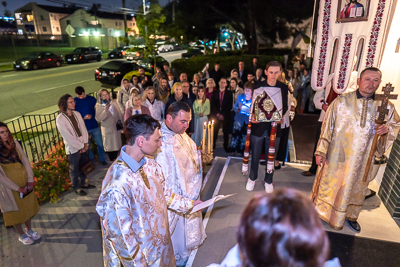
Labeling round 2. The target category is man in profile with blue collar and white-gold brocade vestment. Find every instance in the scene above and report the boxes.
[96,114,193,267]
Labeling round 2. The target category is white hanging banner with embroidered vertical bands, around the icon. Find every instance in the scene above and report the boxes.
[311,0,400,94]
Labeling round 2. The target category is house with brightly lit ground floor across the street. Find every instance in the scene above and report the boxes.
[60,8,139,49]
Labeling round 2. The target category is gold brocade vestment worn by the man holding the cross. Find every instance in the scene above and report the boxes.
[311,92,400,230]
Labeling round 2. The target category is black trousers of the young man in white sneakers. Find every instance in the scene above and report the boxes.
[249,129,280,184]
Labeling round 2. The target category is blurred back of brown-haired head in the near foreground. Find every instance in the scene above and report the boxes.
[237,188,329,267]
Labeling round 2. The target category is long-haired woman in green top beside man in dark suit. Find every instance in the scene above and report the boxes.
[192,86,210,146]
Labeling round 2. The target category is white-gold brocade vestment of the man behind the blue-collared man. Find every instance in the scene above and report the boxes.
[156,123,206,266]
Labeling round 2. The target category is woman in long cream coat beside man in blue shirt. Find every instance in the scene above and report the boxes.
[96,89,123,161]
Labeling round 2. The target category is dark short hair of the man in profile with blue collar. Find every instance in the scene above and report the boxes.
[124,114,161,146]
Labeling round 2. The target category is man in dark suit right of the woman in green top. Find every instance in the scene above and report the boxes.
[210,77,233,151]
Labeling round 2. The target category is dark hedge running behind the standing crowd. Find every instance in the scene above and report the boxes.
[171,55,284,81]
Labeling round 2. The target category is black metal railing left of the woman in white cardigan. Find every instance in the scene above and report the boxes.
[7,111,61,162]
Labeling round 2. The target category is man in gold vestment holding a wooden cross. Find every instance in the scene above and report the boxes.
[311,67,400,232]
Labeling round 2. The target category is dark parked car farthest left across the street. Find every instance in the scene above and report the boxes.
[13,52,64,70]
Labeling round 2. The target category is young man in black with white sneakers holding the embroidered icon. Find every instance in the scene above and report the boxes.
[246,61,289,193]
